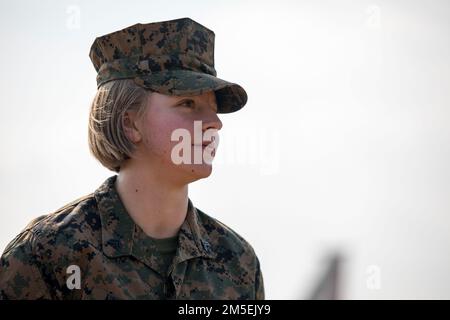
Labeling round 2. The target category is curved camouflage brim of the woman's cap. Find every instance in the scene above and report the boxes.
[134,70,247,113]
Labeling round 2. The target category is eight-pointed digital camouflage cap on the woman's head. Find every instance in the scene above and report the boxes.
[89,18,247,113]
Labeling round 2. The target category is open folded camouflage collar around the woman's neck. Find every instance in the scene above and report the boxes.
[94,175,215,264]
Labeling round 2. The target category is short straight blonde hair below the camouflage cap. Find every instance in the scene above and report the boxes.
[88,79,152,172]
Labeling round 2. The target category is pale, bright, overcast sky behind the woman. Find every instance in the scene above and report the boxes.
[0,0,450,299]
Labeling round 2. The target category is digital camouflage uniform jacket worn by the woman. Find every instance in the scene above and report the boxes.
[0,175,264,299]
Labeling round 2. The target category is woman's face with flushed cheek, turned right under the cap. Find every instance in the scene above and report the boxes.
[124,91,222,184]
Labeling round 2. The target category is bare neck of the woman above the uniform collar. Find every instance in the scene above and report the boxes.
[115,160,188,239]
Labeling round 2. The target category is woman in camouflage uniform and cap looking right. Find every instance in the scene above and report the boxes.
[0,18,264,299]
